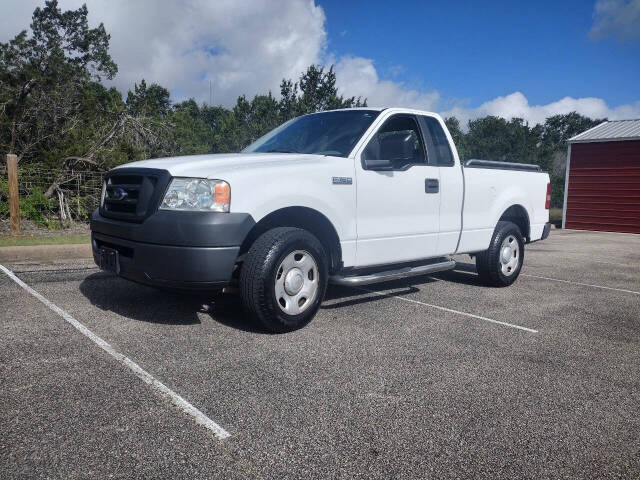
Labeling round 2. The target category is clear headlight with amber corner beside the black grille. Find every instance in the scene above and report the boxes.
[160,178,231,212]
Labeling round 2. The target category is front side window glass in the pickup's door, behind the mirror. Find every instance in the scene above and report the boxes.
[362,115,427,170]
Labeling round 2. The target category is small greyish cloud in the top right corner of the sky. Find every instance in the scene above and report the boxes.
[589,0,640,42]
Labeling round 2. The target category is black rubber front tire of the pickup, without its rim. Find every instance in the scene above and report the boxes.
[240,227,329,333]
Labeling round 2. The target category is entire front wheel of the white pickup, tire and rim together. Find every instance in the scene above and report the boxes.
[240,227,328,333]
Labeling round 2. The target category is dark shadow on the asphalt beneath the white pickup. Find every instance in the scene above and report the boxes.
[80,263,483,334]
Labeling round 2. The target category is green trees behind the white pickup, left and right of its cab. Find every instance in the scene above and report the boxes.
[0,0,602,212]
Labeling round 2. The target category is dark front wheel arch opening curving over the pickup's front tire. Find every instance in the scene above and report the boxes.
[239,207,342,273]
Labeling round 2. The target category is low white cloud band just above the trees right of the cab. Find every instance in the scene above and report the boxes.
[442,92,640,125]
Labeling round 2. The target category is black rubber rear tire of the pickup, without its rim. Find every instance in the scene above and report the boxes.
[476,221,524,287]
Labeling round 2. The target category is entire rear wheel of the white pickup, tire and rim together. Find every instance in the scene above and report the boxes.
[476,221,524,287]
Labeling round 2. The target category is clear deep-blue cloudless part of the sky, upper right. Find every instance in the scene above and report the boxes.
[320,0,640,106]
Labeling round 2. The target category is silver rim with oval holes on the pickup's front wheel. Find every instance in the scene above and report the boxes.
[275,250,318,315]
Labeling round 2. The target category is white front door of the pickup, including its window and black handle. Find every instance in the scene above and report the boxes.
[356,114,440,266]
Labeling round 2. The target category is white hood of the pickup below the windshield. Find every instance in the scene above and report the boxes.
[116,153,336,180]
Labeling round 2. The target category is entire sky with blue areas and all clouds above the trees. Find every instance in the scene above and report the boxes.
[0,0,640,125]
